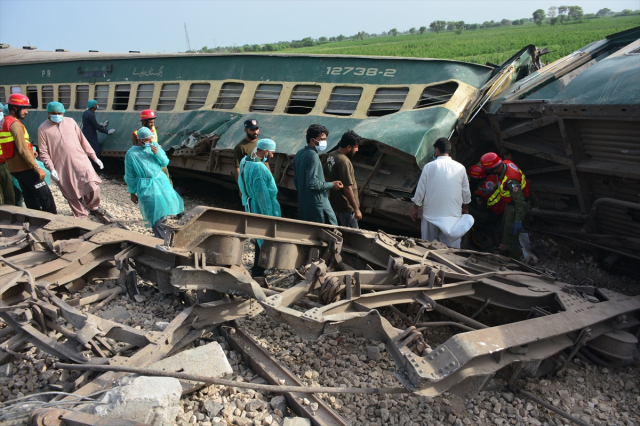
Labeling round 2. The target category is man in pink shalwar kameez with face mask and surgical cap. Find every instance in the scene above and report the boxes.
[38,102,105,219]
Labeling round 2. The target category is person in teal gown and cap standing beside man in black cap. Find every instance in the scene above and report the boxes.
[238,139,282,277]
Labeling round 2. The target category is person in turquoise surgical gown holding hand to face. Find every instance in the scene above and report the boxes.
[124,127,184,239]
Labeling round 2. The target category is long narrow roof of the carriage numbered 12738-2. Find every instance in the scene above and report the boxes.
[0,44,492,69]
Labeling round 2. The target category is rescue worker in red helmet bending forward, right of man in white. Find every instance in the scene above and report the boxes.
[480,152,529,260]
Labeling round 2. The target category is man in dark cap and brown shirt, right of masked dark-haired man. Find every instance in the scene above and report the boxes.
[323,130,362,229]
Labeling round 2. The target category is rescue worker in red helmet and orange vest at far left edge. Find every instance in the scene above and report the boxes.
[0,93,57,214]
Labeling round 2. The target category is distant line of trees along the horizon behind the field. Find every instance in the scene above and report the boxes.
[188,6,640,53]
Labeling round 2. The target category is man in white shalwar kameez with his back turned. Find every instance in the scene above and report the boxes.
[411,138,473,248]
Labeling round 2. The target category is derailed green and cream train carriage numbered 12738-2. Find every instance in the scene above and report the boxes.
[0,45,516,230]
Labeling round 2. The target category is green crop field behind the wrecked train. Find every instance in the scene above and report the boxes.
[282,15,640,64]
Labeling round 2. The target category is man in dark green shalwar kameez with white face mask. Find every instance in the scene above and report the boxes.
[293,124,342,225]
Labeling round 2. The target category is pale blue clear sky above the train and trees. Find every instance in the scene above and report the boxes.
[0,0,640,52]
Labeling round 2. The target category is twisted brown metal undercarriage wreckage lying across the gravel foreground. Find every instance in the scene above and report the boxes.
[0,206,640,412]
